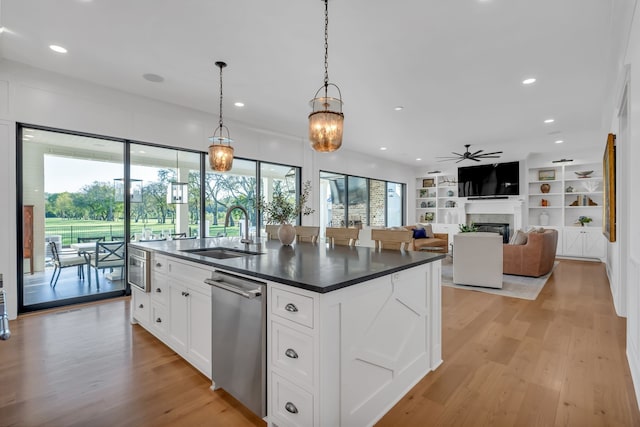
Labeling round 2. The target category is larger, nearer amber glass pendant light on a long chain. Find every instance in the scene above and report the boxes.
[309,0,344,152]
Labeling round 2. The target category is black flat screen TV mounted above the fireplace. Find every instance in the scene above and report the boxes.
[458,162,520,197]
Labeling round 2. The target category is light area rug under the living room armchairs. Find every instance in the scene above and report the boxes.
[442,259,559,300]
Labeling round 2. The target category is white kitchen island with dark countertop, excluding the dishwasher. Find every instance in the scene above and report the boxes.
[130,238,444,426]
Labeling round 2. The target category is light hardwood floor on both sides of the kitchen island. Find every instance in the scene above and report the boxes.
[0,260,640,427]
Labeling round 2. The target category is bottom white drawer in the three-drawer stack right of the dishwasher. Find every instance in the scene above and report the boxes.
[270,374,314,426]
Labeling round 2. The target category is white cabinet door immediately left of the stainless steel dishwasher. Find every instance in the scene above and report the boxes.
[186,288,211,376]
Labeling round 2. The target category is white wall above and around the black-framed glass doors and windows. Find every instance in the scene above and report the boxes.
[0,60,415,318]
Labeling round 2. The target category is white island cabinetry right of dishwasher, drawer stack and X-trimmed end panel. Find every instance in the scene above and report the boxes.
[267,261,441,427]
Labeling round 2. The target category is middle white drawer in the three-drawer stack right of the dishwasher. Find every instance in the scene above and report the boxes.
[270,322,314,387]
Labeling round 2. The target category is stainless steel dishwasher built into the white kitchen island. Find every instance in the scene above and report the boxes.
[205,271,267,417]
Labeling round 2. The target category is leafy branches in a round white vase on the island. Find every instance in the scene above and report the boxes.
[258,181,314,245]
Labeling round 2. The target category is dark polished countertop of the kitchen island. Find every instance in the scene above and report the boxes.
[129,237,444,293]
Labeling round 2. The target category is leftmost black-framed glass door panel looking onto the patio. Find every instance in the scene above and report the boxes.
[19,127,126,311]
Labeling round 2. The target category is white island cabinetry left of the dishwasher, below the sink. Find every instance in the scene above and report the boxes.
[131,253,212,378]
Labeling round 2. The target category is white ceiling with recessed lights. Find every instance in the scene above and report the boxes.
[0,0,635,167]
